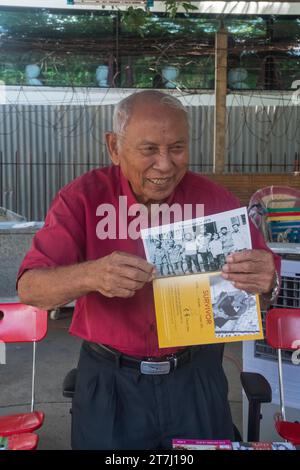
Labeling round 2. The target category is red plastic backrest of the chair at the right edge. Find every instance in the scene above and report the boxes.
[266,308,300,349]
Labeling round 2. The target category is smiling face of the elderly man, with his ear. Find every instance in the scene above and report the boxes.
[107,100,188,205]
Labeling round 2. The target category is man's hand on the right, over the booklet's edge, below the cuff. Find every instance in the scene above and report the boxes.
[222,250,275,294]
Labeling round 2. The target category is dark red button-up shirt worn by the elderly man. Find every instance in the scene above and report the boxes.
[18,166,280,357]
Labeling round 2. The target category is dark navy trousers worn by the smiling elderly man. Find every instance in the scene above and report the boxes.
[72,345,233,450]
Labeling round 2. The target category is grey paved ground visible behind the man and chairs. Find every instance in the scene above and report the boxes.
[0,311,242,450]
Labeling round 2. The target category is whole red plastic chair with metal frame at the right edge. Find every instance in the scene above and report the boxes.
[266,308,300,445]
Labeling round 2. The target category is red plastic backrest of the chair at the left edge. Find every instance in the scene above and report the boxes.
[0,303,48,343]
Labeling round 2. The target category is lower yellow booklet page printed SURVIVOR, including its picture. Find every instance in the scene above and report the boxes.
[153,273,263,348]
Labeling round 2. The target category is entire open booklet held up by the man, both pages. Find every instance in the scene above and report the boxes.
[141,207,263,348]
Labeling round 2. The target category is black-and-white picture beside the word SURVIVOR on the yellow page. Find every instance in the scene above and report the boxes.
[209,275,259,337]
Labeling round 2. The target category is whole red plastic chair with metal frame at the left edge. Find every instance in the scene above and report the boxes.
[0,303,47,438]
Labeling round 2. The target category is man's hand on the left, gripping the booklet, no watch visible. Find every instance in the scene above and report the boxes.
[89,251,155,298]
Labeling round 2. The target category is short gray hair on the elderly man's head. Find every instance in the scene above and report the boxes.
[113,90,188,135]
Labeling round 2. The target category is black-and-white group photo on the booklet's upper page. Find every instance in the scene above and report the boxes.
[143,210,251,277]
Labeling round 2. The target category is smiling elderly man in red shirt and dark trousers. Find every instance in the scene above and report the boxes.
[18,91,278,449]
